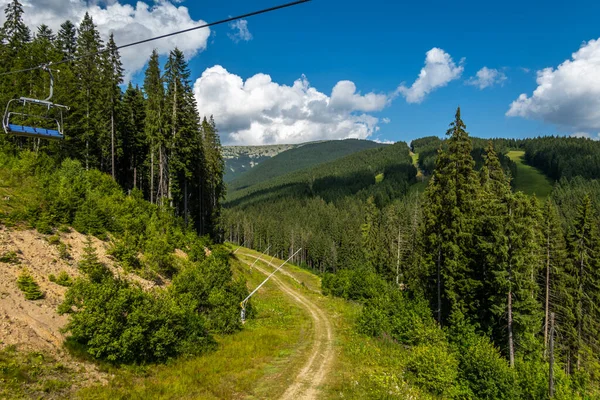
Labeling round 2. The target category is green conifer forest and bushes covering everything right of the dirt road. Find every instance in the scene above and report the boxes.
[224,110,600,399]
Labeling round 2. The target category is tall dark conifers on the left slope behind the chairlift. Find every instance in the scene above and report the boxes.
[0,0,224,235]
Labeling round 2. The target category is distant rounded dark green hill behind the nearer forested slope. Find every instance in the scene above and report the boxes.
[229,139,385,192]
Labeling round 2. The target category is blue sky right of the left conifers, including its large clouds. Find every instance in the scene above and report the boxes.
[7,0,600,144]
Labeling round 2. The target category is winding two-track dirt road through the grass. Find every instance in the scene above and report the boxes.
[240,251,334,400]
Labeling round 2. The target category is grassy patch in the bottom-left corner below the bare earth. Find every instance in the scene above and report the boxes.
[0,346,77,399]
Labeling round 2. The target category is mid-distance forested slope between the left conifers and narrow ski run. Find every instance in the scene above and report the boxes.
[223,142,416,272]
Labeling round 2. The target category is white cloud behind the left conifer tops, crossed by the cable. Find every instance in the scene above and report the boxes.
[0,0,210,78]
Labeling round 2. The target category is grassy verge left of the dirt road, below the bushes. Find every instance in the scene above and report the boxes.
[79,255,311,399]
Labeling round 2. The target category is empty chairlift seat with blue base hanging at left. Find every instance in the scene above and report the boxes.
[2,64,69,139]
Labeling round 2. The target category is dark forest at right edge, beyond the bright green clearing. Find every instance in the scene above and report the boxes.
[523,136,600,181]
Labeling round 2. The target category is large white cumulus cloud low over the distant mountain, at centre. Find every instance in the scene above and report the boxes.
[194,65,388,144]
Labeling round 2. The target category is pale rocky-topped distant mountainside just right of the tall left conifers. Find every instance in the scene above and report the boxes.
[223,144,299,182]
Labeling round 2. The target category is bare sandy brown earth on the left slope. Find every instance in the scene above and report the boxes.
[0,225,155,386]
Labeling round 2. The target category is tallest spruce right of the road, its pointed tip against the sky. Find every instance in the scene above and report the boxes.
[424,107,479,323]
